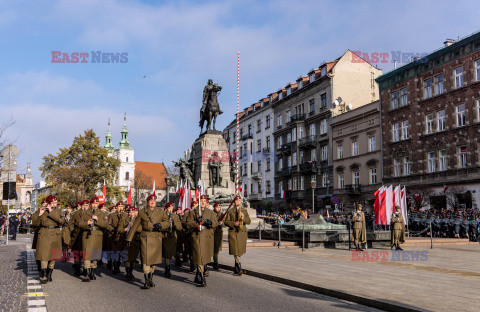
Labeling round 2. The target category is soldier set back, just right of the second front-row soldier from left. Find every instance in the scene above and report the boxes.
[108,202,129,274]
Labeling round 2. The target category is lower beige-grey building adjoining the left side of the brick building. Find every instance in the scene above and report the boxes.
[331,101,382,211]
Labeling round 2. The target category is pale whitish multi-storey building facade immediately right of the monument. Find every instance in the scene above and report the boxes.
[223,98,275,211]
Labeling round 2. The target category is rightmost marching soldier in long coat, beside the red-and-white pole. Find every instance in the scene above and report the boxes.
[225,195,251,275]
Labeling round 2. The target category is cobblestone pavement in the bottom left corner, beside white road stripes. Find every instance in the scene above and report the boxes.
[0,235,31,311]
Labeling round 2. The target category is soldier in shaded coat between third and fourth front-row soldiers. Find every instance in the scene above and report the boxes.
[162,202,182,278]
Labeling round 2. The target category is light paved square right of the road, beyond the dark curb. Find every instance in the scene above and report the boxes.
[220,245,480,311]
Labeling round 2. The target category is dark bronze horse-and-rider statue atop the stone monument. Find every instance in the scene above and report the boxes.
[199,79,223,135]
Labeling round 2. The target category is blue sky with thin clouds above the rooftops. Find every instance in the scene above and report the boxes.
[0,0,480,182]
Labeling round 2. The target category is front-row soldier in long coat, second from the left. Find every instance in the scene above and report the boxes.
[79,197,113,282]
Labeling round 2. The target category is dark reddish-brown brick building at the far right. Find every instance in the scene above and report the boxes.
[377,33,480,208]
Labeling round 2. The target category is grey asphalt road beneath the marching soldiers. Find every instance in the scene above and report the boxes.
[43,262,378,312]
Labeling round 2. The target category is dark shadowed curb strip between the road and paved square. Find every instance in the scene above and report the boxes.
[219,264,425,312]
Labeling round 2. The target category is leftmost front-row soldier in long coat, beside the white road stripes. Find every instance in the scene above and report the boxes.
[32,195,65,284]
